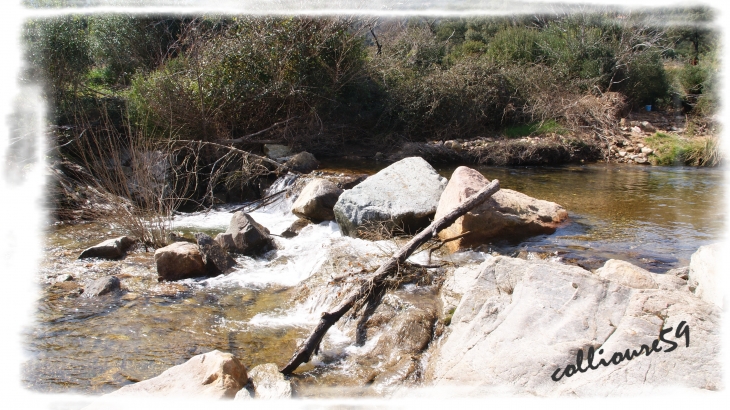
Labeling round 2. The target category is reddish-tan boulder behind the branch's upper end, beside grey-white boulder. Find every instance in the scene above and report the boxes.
[434,167,568,252]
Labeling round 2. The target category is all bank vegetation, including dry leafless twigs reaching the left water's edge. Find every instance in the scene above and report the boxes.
[22,7,719,234]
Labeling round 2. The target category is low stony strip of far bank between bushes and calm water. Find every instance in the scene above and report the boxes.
[302,111,723,167]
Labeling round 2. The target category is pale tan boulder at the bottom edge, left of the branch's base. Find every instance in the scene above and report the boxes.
[88,350,248,399]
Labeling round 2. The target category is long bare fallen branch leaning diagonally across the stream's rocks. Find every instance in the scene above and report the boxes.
[280,179,499,374]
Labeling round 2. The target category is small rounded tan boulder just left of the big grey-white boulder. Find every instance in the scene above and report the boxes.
[291,178,343,222]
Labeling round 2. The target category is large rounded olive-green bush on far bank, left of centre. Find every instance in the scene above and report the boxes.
[129,18,365,140]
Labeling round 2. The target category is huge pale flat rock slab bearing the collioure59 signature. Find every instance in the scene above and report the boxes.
[426,256,722,396]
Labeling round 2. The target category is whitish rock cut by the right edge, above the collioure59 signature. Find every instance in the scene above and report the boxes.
[688,243,725,308]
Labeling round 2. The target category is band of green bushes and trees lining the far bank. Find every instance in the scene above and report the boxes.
[25,8,718,151]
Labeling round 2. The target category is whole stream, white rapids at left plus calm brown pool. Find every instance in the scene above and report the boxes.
[23,162,725,395]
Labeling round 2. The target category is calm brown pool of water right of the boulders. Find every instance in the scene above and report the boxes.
[325,161,726,272]
